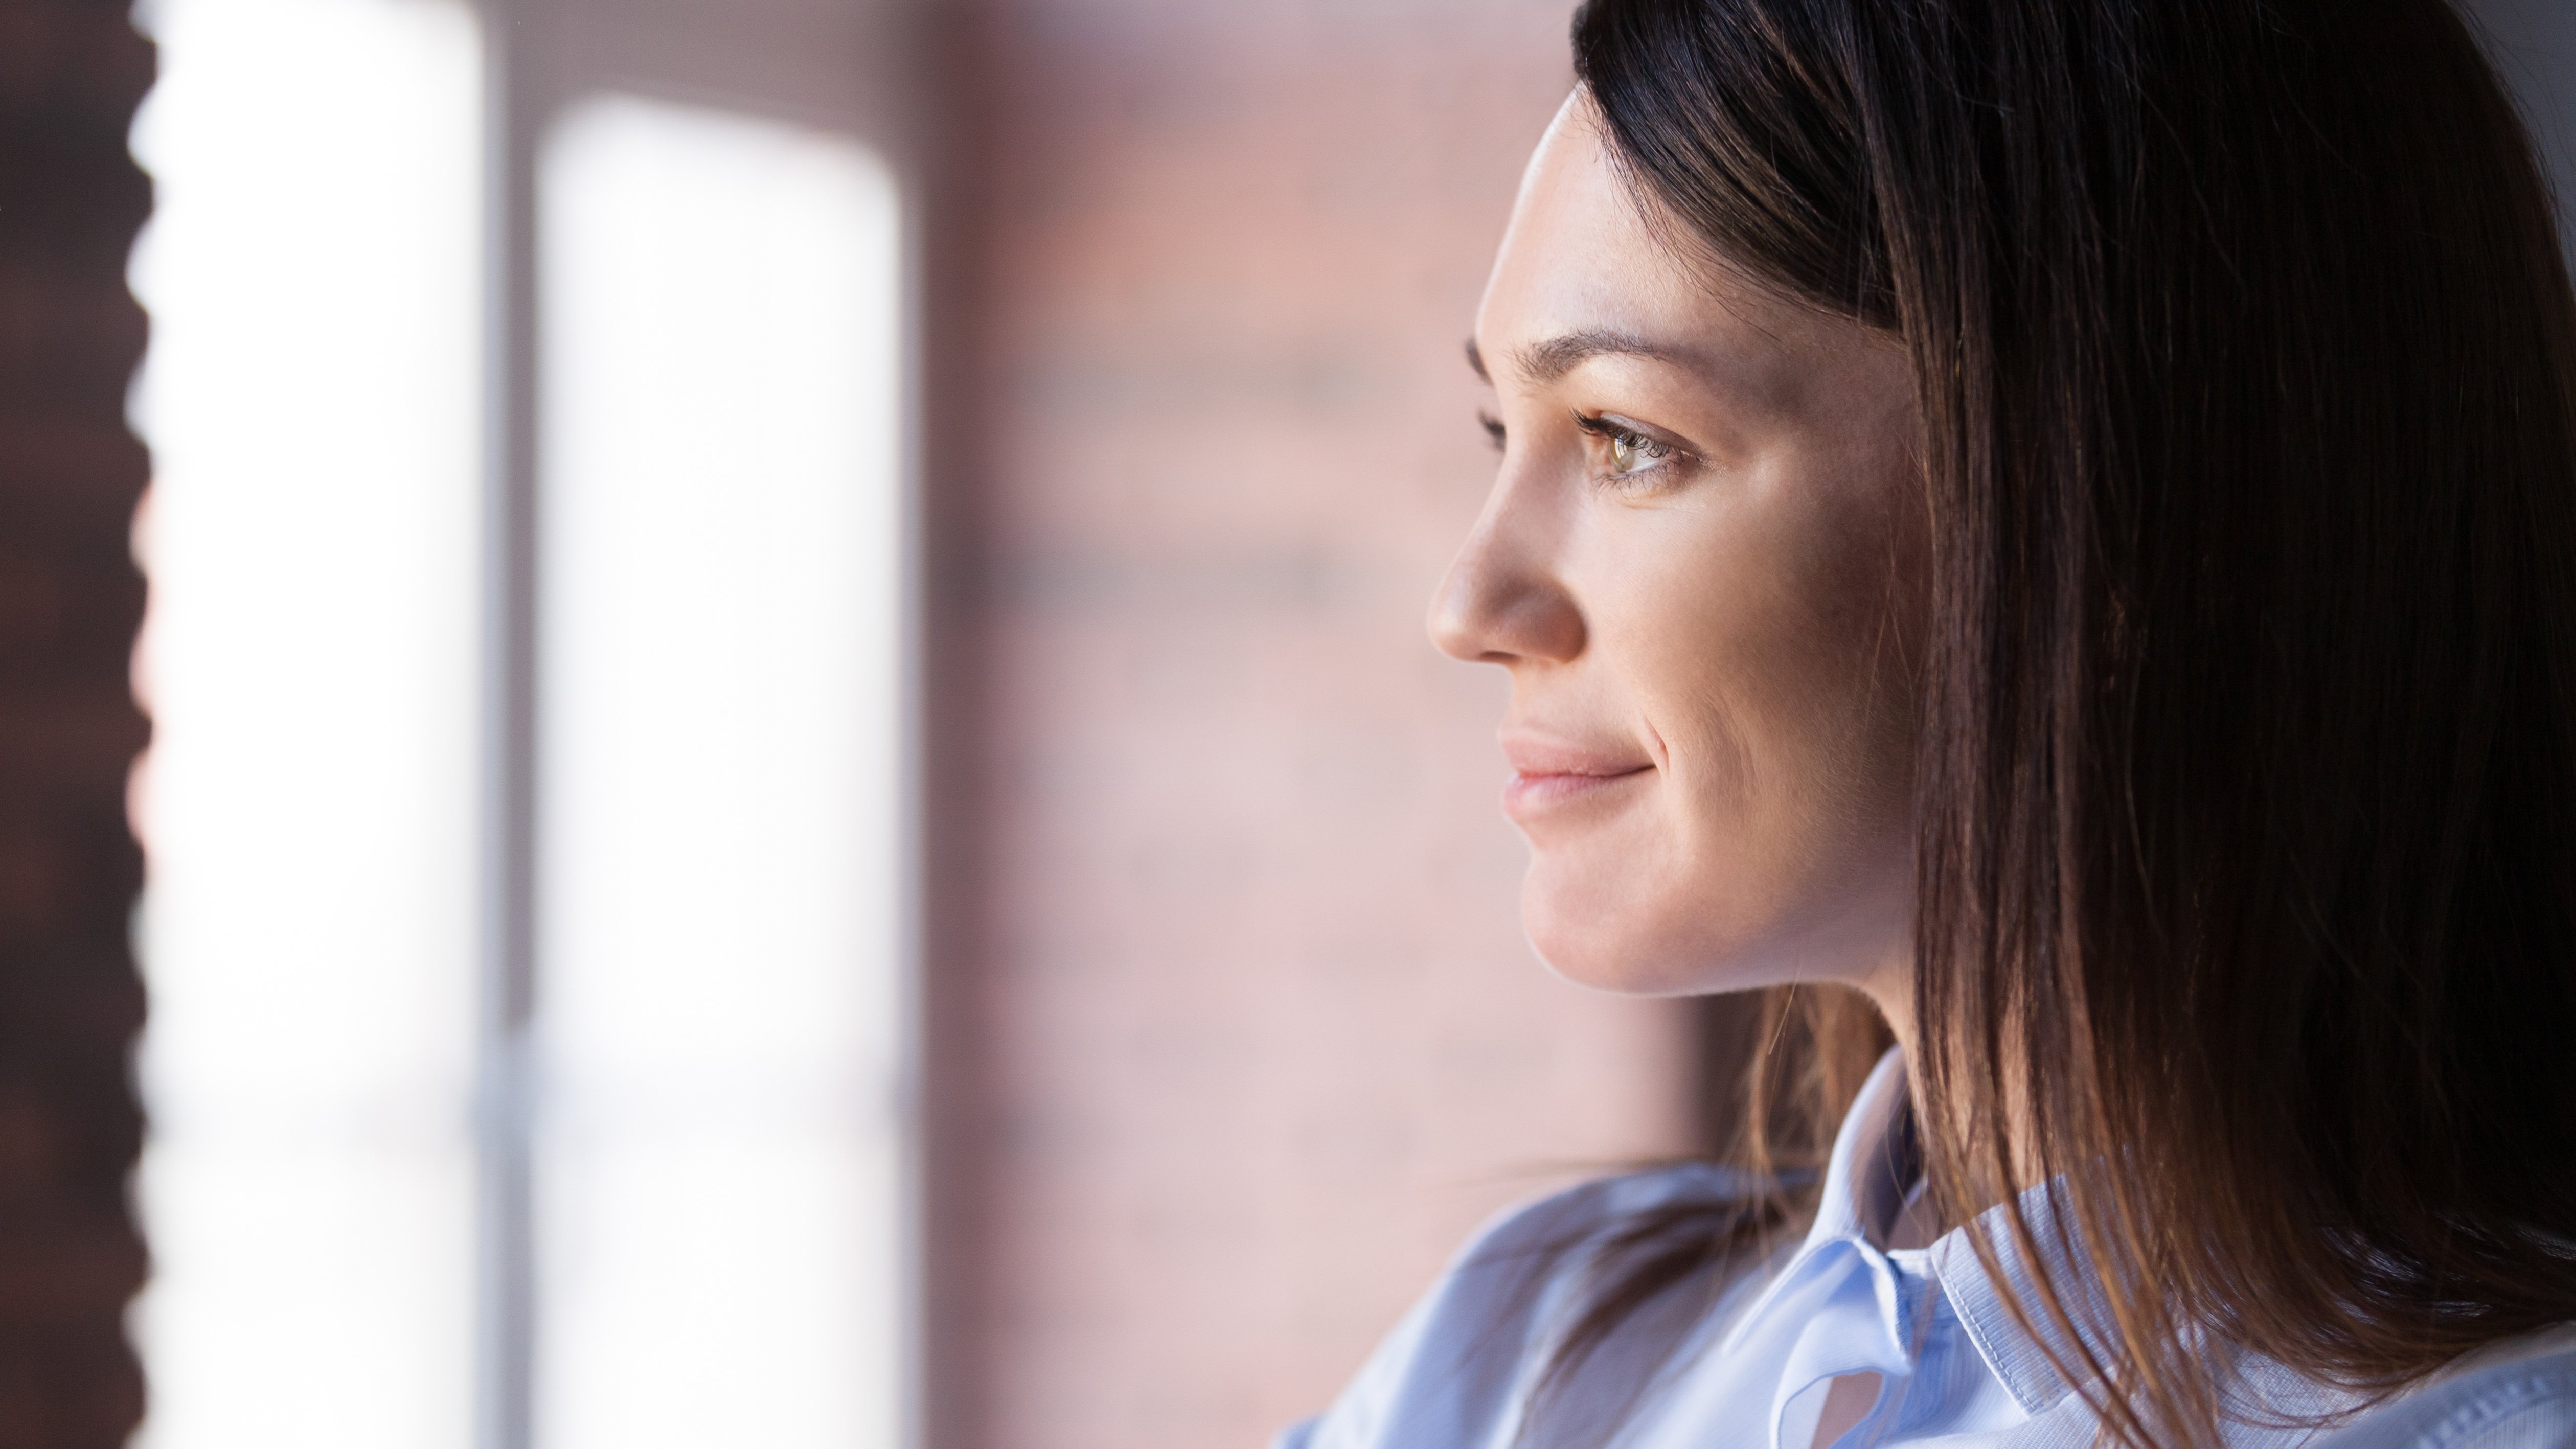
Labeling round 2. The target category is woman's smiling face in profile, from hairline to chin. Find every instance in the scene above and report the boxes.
[1430,93,1927,994]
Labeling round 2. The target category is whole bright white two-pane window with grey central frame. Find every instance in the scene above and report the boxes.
[134,0,912,1449]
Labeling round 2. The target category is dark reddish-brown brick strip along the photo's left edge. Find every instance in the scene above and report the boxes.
[0,0,152,1449]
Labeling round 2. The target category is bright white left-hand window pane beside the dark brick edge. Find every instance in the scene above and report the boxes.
[134,0,482,1449]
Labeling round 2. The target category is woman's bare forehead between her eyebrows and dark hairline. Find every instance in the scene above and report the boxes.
[1476,93,1813,381]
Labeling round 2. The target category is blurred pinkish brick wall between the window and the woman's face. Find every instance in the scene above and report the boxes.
[927,0,1695,1449]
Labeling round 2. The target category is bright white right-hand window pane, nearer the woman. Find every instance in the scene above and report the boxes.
[536,98,907,1449]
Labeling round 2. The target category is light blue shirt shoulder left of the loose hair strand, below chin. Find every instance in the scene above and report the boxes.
[1280,1163,1752,1449]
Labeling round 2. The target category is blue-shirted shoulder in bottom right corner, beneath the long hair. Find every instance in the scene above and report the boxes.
[2318,1325,2576,1449]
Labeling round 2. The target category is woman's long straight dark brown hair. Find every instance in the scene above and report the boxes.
[1551,0,2576,1449]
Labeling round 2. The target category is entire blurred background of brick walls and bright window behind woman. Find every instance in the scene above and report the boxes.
[0,0,2576,1449]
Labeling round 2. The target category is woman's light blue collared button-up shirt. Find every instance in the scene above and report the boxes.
[1278,1053,2576,1449]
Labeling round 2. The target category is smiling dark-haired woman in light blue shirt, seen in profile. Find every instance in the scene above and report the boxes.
[1285,0,2576,1449]
